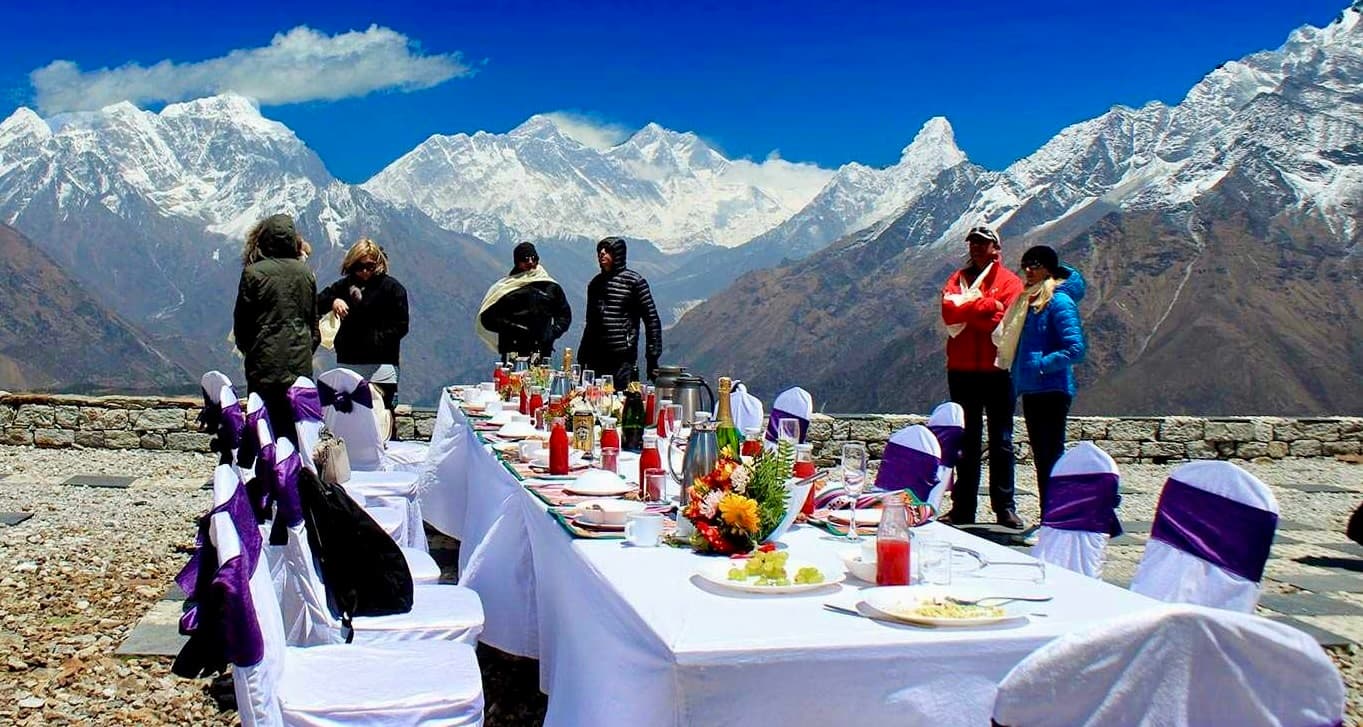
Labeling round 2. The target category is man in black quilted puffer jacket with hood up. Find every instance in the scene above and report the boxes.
[578,237,662,390]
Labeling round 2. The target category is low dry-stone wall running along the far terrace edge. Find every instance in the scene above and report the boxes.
[0,391,1363,465]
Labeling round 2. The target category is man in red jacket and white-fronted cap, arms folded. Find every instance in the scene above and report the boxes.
[939,226,1024,529]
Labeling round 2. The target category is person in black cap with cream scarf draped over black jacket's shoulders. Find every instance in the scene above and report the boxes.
[474,243,572,360]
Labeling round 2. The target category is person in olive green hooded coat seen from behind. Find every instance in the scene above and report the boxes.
[232,214,322,441]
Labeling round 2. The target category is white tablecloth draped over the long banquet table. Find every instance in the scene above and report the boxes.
[421,394,1159,726]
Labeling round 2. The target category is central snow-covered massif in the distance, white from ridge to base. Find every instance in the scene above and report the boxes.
[364,116,830,251]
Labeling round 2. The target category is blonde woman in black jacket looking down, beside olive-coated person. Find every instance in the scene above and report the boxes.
[318,239,408,412]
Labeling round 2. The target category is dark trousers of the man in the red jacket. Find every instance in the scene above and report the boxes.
[946,371,1015,522]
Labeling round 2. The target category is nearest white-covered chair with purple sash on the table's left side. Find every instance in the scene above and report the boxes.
[200,461,483,727]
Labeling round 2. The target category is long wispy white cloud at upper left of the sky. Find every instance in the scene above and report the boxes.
[29,26,474,113]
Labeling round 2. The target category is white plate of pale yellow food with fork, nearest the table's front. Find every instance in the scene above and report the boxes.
[861,585,1026,626]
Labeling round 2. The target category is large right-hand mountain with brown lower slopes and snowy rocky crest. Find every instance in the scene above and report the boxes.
[667,3,1363,415]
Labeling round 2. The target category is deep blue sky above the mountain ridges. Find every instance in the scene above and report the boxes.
[0,0,1348,181]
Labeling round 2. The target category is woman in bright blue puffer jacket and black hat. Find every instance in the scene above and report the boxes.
[1000,246,1086,506]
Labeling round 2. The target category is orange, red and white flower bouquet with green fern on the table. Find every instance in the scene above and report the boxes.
[683,442,795,555]
